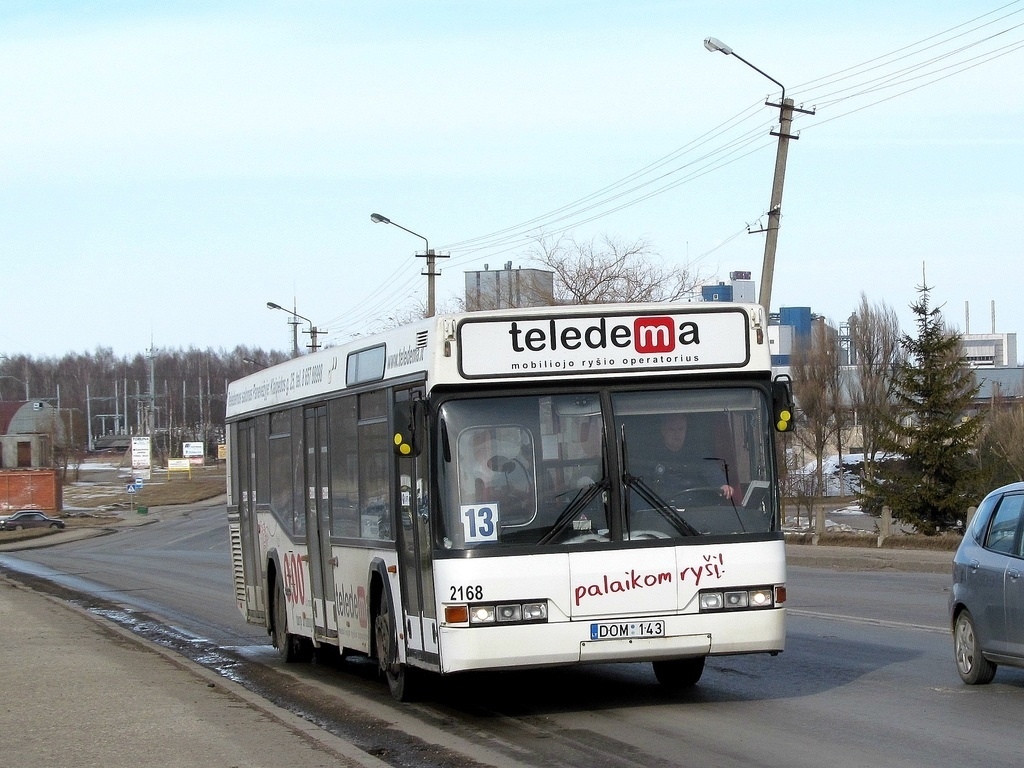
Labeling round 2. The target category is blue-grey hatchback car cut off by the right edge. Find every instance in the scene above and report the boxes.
[949,482,1024,685]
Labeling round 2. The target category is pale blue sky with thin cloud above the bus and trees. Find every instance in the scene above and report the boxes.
[0,0,1024,357]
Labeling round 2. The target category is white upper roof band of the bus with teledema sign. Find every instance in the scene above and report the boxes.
[227,302,771,420]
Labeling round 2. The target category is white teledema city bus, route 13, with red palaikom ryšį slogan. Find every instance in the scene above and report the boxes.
[227,303,792,699]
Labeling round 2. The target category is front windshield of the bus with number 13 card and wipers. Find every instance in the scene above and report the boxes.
[437,387,777,550]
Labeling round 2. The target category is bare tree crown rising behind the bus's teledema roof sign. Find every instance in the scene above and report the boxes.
[530,234,705,304]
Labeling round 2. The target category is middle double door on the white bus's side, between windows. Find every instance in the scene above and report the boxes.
[303,406,338,639]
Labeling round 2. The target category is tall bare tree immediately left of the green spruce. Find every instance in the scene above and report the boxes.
[850,294,903,478]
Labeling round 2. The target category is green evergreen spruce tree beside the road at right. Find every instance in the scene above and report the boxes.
[865,286,981,535]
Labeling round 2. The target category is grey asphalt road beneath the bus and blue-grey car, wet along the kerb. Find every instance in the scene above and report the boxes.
[0,507,1024,768]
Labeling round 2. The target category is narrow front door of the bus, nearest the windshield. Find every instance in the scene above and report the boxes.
[394,389,438,665]
